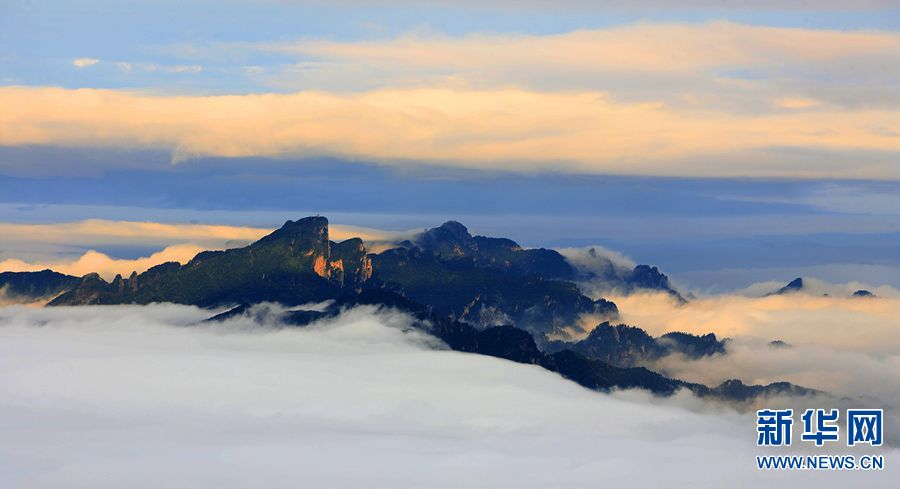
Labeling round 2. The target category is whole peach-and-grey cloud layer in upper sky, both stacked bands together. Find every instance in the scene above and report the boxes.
[0,21,900,179]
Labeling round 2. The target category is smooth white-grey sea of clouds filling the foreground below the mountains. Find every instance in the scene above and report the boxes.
[0,305,897,488]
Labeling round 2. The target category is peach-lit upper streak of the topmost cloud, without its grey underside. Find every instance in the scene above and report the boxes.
[276,21,900,76]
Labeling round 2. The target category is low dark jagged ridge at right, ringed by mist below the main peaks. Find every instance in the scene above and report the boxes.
[548,322,725,367]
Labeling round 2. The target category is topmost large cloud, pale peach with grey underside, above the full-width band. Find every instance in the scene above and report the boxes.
[241,21,900,110]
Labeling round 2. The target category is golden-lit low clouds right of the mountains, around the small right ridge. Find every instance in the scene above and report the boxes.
[612,288,900,418]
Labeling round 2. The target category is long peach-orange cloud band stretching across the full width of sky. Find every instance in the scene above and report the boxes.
[0,87,900,178]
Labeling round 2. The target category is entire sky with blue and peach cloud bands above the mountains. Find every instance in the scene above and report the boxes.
[0,0,900,292]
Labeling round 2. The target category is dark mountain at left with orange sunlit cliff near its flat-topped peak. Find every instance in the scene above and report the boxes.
[50,217,372,307]
